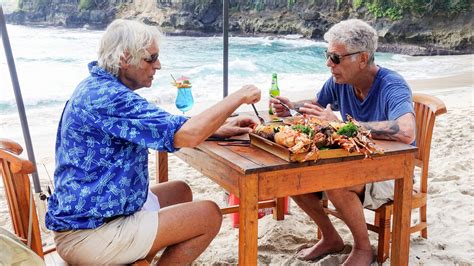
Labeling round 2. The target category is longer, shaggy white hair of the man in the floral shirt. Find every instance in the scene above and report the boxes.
[98,19,162,76]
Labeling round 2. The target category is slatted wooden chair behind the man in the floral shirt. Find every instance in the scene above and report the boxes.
[0,139,149,265]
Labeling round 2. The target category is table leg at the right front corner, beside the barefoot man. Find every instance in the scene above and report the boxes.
[390,154,414,265]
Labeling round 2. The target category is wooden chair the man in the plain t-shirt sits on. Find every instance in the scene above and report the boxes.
[318,94,447,263]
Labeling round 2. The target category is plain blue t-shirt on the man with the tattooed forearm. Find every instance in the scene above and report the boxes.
[316,67,414,122]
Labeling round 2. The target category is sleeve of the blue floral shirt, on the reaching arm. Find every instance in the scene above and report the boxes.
[91,91,187,152]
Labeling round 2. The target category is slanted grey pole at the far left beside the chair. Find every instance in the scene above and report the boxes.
[0,5,46,199]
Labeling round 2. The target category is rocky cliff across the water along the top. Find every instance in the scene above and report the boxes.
[7,0,474,55]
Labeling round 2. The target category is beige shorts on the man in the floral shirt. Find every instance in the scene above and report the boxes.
[54,211,158,265]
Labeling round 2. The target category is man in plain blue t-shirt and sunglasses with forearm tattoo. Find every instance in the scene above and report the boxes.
[270,19,415,265]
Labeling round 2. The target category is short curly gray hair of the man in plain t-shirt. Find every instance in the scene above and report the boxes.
[324,19,378,63]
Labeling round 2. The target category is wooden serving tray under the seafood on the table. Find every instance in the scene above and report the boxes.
[249,133,360,162]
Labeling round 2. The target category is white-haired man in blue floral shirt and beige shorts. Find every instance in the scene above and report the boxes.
[46,20,260,264]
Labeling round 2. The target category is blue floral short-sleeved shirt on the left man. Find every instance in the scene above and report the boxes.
[46,62,186,231]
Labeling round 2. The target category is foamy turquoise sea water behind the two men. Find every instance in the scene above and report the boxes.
[0,25,468,159]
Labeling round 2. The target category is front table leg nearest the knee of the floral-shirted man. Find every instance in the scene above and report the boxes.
[239,175,258,265]
